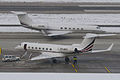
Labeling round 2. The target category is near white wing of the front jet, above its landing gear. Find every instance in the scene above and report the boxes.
[31,52,65,60]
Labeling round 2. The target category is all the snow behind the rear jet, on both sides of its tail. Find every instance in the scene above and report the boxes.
[0,13,120,32]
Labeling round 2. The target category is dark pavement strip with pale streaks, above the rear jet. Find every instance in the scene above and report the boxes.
[0,2,120,14]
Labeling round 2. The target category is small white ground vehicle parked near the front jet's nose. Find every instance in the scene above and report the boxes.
[2,55,20,62]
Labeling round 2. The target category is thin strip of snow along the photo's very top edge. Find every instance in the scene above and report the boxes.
[0,0,120,2]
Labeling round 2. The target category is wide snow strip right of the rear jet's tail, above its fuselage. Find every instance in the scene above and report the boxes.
[29,14,120,25]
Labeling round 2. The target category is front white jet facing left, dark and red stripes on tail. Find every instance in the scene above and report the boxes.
[15,33,115,60]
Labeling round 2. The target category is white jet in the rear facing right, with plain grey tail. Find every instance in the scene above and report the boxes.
[11,11,102,37]
